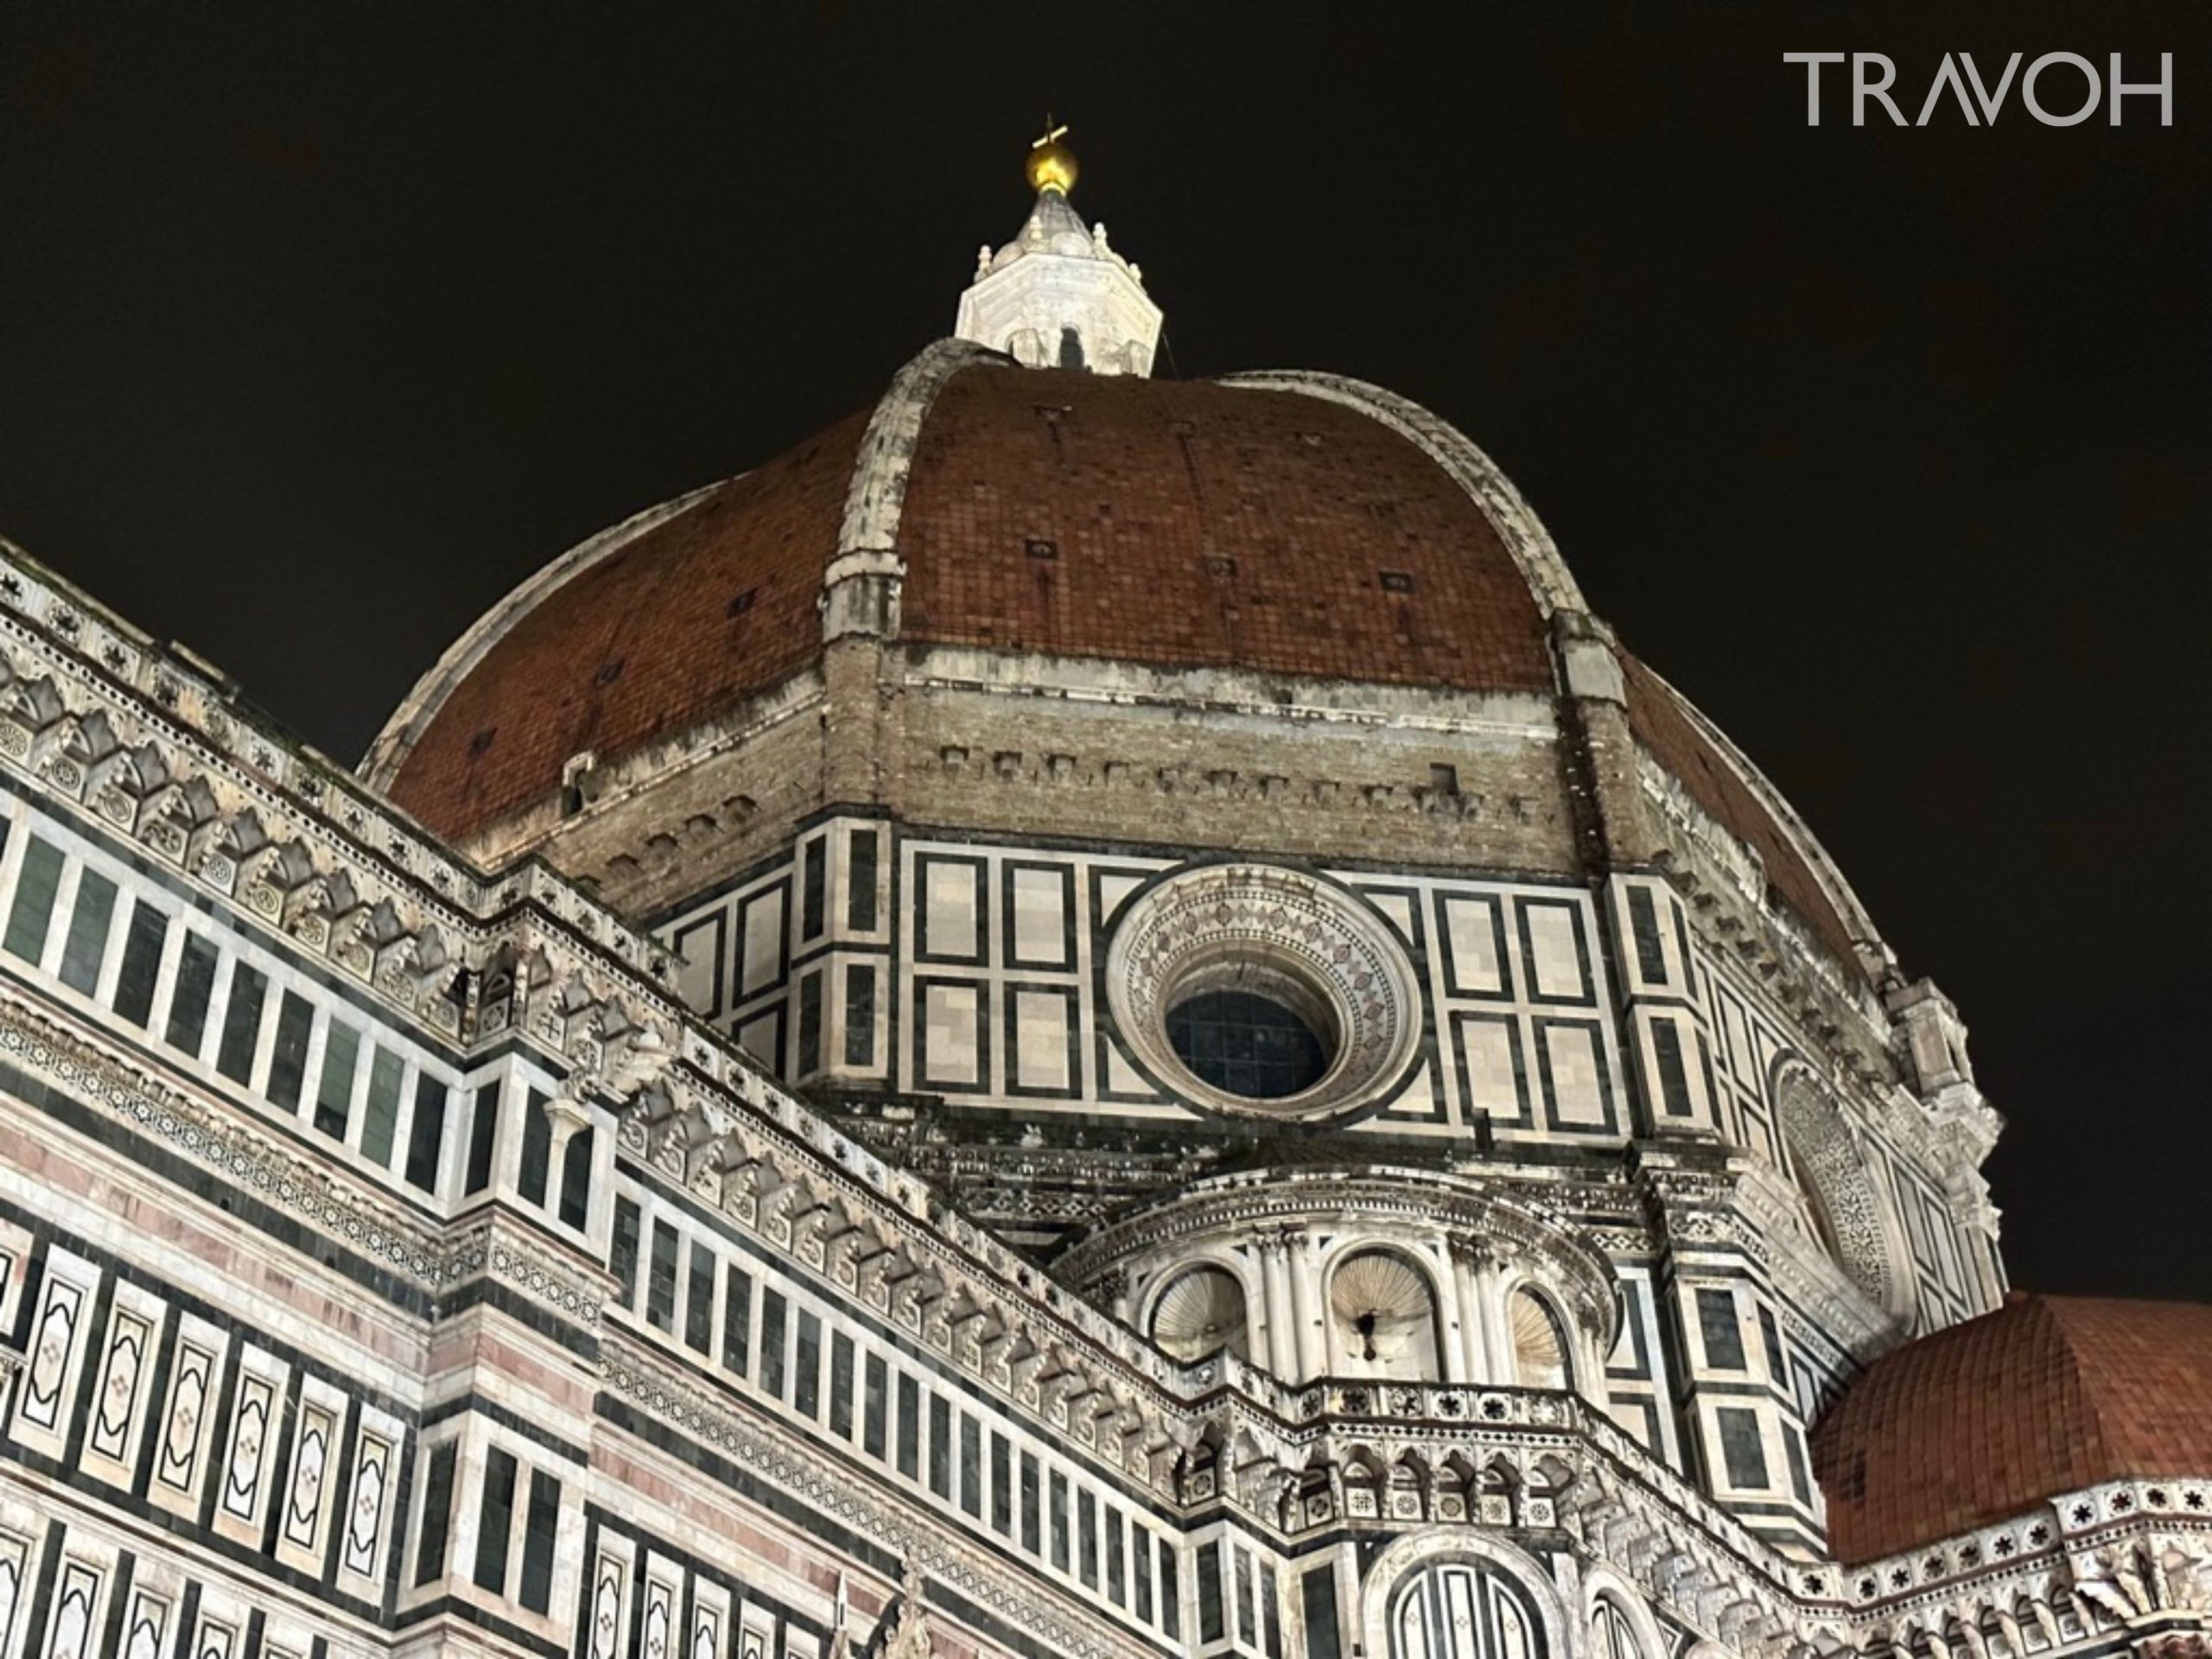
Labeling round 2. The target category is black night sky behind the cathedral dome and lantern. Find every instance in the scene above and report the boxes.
[0,0,2212,1299]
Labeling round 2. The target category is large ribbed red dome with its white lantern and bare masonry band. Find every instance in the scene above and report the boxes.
[363,145,1887,986]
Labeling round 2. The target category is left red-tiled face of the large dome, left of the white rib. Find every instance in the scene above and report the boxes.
[391,414,868,838]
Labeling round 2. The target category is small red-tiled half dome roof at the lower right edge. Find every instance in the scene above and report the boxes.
[1812,1294,2212,1561]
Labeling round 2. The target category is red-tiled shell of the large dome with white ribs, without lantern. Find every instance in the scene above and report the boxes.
[363,340,1872,982]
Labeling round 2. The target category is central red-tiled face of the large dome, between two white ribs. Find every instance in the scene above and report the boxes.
[898,367,1553,695]
